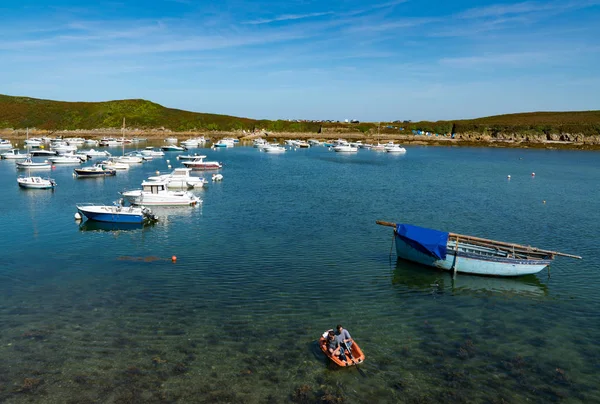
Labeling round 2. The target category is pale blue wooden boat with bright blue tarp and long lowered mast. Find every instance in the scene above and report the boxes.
[376,220,581,276]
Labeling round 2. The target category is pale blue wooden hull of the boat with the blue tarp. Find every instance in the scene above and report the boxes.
[395,233,552,276]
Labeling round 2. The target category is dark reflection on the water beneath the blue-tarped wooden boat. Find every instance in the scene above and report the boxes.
[392,258,548,297]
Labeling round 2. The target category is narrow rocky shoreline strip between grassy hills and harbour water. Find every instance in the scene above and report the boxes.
[0,128,600,150]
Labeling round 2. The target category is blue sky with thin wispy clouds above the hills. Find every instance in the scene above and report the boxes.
[0,0,600,121]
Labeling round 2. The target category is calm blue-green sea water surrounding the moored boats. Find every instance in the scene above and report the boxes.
[0,146,600,403]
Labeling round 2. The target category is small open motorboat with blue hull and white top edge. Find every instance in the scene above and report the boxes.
[76,201,157,223]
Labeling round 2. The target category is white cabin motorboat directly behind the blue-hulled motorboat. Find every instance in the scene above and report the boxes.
[121,181,202,206]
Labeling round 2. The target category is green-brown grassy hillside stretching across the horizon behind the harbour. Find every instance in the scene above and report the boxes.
[0,95,600,136]
